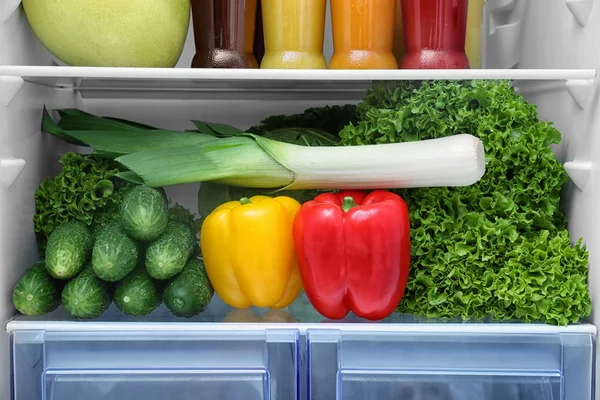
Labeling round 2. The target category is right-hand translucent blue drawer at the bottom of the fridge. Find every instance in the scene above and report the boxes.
[307,330,594,400]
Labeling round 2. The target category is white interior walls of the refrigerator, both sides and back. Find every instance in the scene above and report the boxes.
[0,0,600,399]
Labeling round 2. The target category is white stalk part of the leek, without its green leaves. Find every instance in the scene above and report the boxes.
[256,134,485,189]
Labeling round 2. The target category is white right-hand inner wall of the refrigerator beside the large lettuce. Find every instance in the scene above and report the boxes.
[482,0,600,372]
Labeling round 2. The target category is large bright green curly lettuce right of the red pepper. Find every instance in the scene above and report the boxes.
[340,81,591,325]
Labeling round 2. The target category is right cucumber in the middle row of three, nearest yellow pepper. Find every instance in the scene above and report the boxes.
[146,220,195,280]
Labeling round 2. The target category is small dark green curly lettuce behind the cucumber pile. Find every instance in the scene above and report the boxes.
[33,152,131,249]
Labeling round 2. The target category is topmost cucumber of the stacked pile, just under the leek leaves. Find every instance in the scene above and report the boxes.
[120,185,169,241]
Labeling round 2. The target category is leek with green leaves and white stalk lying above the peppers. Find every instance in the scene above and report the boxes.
[116,134,485,189]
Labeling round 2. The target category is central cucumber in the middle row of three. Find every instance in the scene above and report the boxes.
[92,223,138,282]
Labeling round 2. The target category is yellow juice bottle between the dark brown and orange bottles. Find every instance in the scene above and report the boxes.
[260,0,327,69]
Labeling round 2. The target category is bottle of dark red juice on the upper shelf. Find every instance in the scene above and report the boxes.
[400,0,469,69]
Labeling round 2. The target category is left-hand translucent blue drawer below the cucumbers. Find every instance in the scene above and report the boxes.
[12,329,299,400]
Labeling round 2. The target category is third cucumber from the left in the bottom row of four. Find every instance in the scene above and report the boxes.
[113,268,162,317]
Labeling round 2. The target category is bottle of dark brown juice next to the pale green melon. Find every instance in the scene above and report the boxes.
[192,0,258,68]
